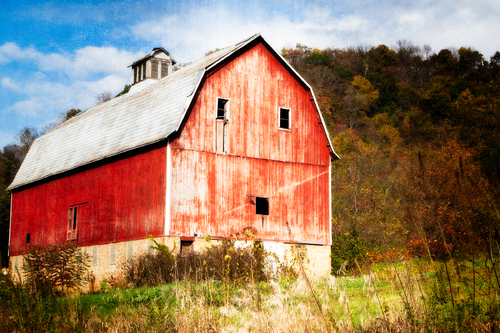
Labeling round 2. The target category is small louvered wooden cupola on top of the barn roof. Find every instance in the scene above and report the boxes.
[128,47,177,86]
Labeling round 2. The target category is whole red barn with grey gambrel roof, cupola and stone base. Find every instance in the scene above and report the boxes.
[9,35,338,275]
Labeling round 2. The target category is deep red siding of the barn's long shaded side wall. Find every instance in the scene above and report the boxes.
[10,147,166,255]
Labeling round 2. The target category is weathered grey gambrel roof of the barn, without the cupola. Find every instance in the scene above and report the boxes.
[8,34,338,190]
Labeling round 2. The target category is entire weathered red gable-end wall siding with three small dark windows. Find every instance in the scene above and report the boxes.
[171,44,330,244]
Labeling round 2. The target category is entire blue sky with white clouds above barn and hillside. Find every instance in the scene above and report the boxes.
[0,0,500,149]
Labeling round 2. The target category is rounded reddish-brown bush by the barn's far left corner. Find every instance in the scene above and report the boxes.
[22,242,89,295]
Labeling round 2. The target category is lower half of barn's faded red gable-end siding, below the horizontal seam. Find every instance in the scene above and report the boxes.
[171,149,330,244]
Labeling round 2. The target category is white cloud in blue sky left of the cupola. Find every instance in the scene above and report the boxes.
[0,43,135,122]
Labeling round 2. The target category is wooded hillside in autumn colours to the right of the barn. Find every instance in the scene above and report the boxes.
[282,41,500,270]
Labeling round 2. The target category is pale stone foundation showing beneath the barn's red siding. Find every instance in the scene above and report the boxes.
[9,236,331,288]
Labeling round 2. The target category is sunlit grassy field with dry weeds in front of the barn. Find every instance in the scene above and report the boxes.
[1,259,500,332]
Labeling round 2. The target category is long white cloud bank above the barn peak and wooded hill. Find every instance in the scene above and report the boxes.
[131,0,500,62]
